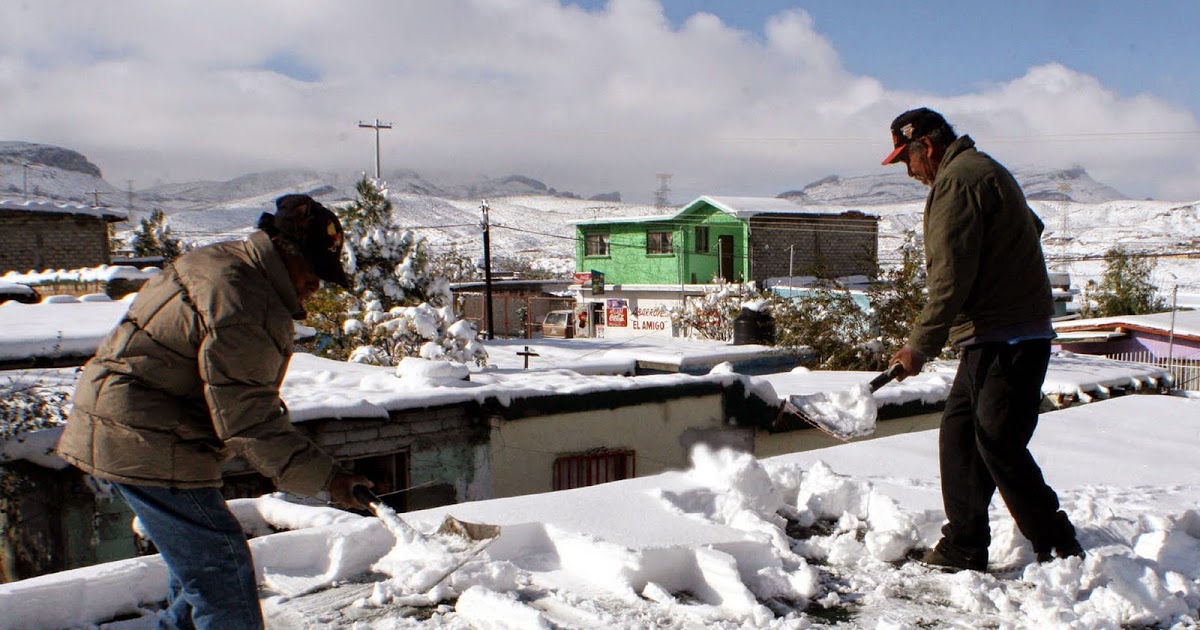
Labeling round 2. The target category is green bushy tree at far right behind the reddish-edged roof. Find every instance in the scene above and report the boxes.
[1081,247,1168,317]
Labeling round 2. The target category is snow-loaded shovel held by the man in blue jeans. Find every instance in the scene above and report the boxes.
[354,486,500,594]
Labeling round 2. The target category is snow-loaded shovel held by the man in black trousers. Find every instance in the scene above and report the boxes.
[772,364,904,442]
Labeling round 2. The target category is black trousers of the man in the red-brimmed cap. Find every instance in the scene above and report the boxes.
[938,340,1075,568]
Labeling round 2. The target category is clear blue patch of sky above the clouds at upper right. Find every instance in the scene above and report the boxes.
[590,0,1200,113]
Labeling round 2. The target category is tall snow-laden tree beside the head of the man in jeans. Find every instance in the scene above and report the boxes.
[338,178,487,365]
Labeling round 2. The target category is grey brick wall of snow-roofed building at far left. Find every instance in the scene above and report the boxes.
[0,210,110,274]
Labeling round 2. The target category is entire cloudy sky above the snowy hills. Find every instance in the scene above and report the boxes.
[0,0,1200,203]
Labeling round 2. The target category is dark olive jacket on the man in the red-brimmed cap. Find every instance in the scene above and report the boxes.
[908,136,1054,359]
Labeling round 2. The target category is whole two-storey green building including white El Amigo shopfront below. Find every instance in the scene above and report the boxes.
[575,196,878,336]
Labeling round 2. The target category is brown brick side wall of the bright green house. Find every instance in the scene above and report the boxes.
[750,211,880,282]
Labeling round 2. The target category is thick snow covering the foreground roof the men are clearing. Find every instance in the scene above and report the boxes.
[0,396,1200,630]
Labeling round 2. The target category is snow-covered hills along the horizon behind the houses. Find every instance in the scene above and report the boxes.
[0,142,1200,295]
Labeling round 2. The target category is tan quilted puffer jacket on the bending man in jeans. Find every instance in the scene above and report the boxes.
[58,232,336,496]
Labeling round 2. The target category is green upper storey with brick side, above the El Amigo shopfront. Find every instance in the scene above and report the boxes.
[575,196,878,286]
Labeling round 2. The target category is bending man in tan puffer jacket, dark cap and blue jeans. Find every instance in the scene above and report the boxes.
[58,194,371,630]
